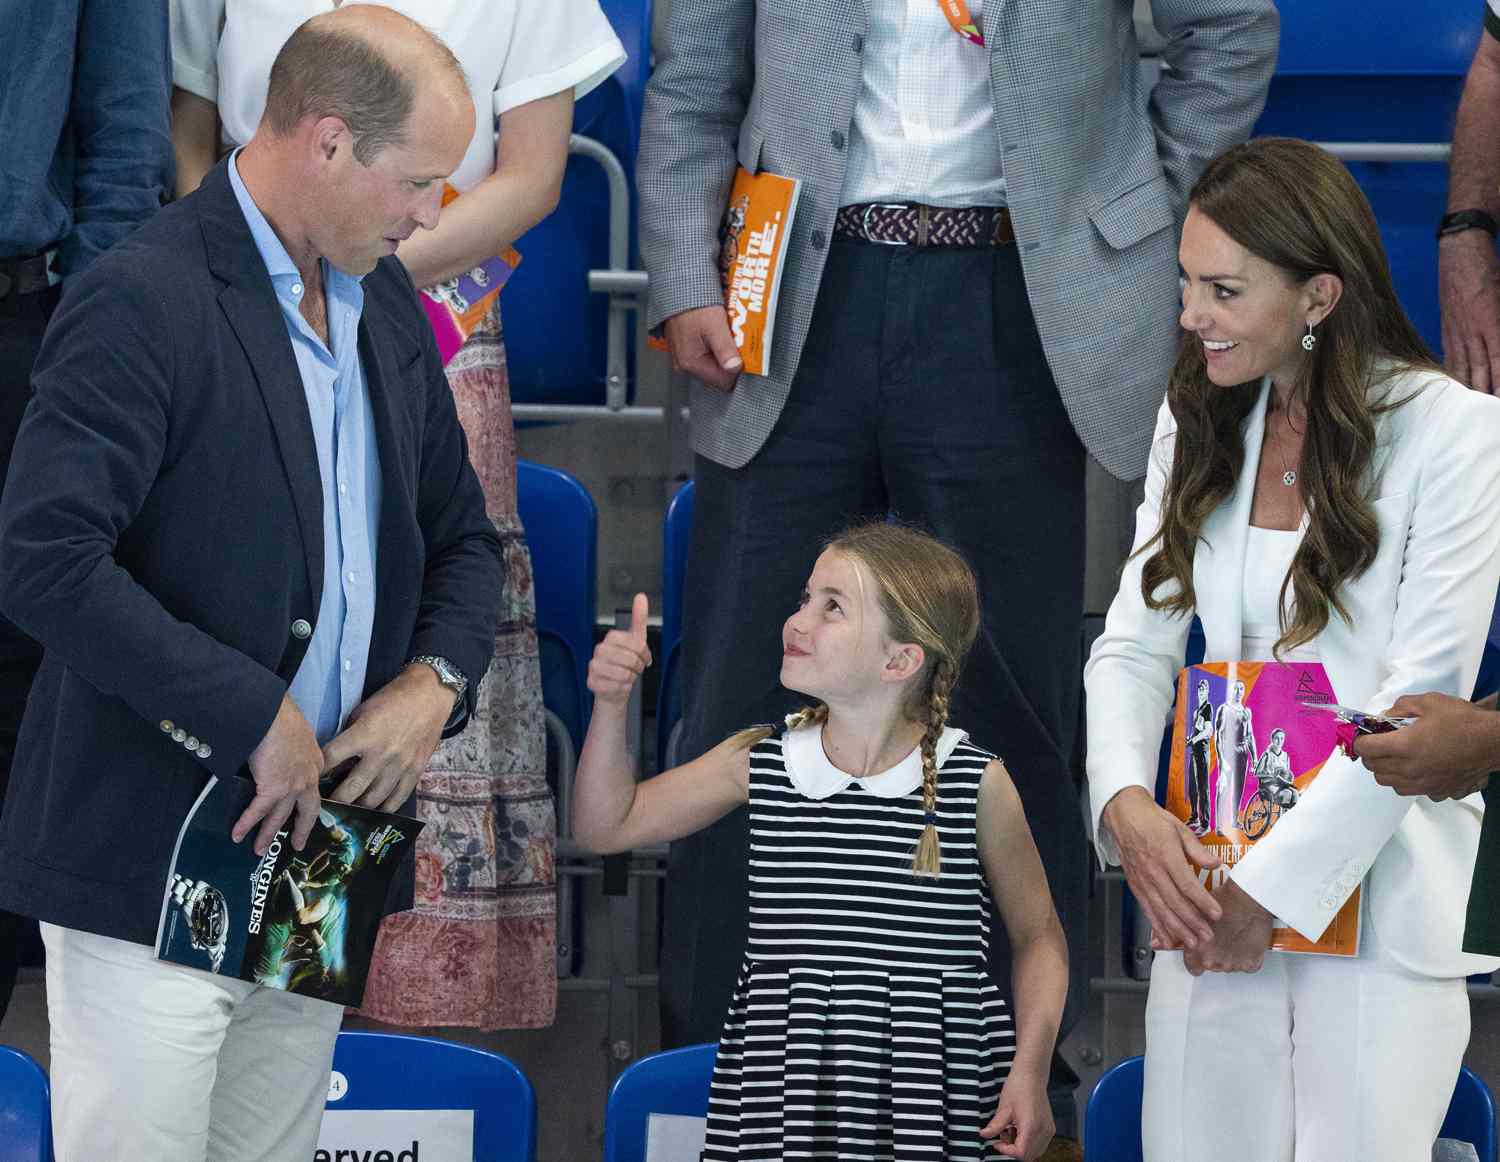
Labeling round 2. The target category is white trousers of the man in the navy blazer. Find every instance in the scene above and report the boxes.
[42,924,344,1162]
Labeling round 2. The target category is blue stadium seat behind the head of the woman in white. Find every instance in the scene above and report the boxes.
[1256,0,1484,351]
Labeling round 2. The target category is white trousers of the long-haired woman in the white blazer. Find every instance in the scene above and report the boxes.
[1142,918,1469,1162]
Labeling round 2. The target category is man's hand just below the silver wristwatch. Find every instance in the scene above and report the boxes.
[323,661,453,811]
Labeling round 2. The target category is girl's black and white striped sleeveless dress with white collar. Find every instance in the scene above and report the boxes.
[702,726,1016,1162]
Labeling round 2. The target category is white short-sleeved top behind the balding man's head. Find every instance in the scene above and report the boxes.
[171,0,626,190]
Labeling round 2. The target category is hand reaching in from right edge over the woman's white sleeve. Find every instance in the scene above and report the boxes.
[1355,694,1500,802]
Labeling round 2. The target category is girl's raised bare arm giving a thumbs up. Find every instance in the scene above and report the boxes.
[573,594,750,855]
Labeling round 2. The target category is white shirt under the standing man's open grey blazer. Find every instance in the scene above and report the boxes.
[840,0,1005,205]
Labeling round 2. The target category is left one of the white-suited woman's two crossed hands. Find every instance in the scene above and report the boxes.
[1101,787,1221,948]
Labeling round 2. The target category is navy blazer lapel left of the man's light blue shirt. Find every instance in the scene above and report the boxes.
[198,163,323,609]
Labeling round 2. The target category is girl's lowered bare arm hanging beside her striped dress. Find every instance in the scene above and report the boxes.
[978,760,1068,1158]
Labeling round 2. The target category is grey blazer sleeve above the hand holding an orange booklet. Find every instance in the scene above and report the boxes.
[636,0,756,328]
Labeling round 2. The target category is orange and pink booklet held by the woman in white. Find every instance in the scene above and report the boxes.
[1166,661,1362,957]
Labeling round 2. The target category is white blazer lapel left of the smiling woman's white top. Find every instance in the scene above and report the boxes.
[1193,378,1271,661]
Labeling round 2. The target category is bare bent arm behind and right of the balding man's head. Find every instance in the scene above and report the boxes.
[398,88,573,286]
